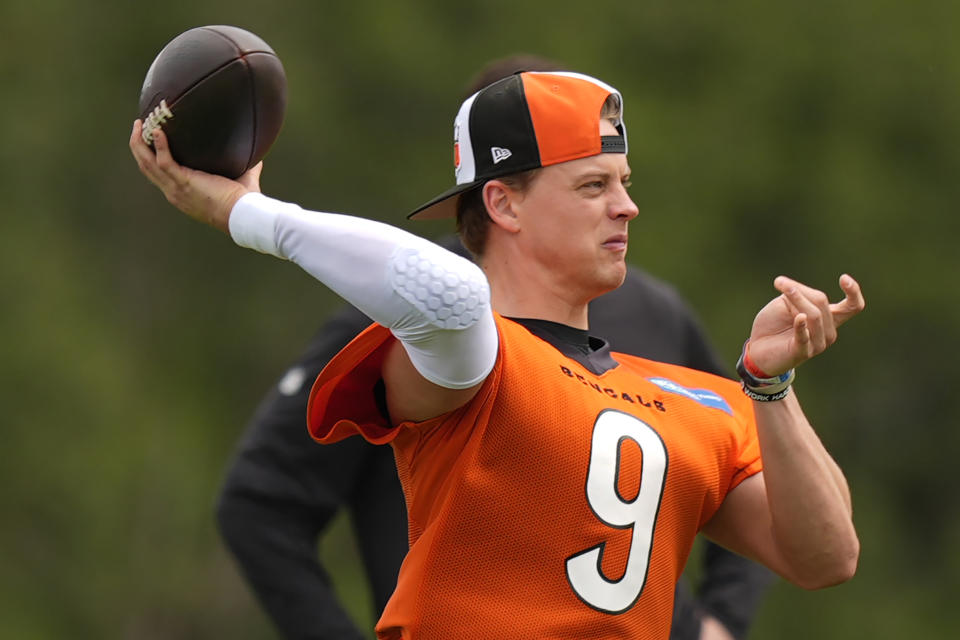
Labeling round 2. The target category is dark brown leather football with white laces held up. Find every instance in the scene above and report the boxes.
[139,25,287,178]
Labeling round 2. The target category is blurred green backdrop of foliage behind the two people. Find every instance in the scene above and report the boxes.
[0,0,960,640]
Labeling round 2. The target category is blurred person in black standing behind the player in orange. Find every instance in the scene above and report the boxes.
[217,55,773,640]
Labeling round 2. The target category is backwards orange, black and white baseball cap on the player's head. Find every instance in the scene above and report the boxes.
[407,71,627,220]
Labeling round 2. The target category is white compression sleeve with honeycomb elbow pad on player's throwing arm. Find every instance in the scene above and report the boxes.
[229,193,498,389]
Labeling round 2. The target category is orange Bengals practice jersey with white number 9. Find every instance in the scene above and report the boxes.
[308,316,761,640]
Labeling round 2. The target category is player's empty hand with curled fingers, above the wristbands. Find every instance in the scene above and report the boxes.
[747,274,866,376]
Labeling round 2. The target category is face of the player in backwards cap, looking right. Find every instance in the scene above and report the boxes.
[517,120,638,298]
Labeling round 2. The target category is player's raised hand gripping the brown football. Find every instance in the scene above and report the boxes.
[130,120,263,232]
